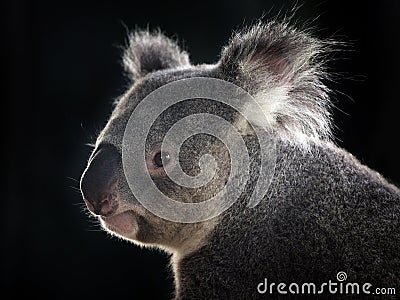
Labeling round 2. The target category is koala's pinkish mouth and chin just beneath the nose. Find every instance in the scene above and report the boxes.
[100,210,138,237]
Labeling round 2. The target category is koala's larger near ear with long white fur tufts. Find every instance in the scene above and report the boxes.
[219,22,331,144]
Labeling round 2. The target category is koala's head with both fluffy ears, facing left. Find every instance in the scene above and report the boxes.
[81,22,330,251]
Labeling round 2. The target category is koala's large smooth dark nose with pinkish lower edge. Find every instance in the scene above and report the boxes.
[81,145,121,216]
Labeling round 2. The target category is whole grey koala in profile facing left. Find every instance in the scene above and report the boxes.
[81,21,400,299]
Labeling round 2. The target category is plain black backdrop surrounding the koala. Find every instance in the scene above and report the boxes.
[0,0,400,299]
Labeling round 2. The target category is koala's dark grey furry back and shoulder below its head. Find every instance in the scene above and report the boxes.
[176,141,400,299]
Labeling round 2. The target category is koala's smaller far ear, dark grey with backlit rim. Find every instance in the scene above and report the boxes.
[122,31,190,80]
